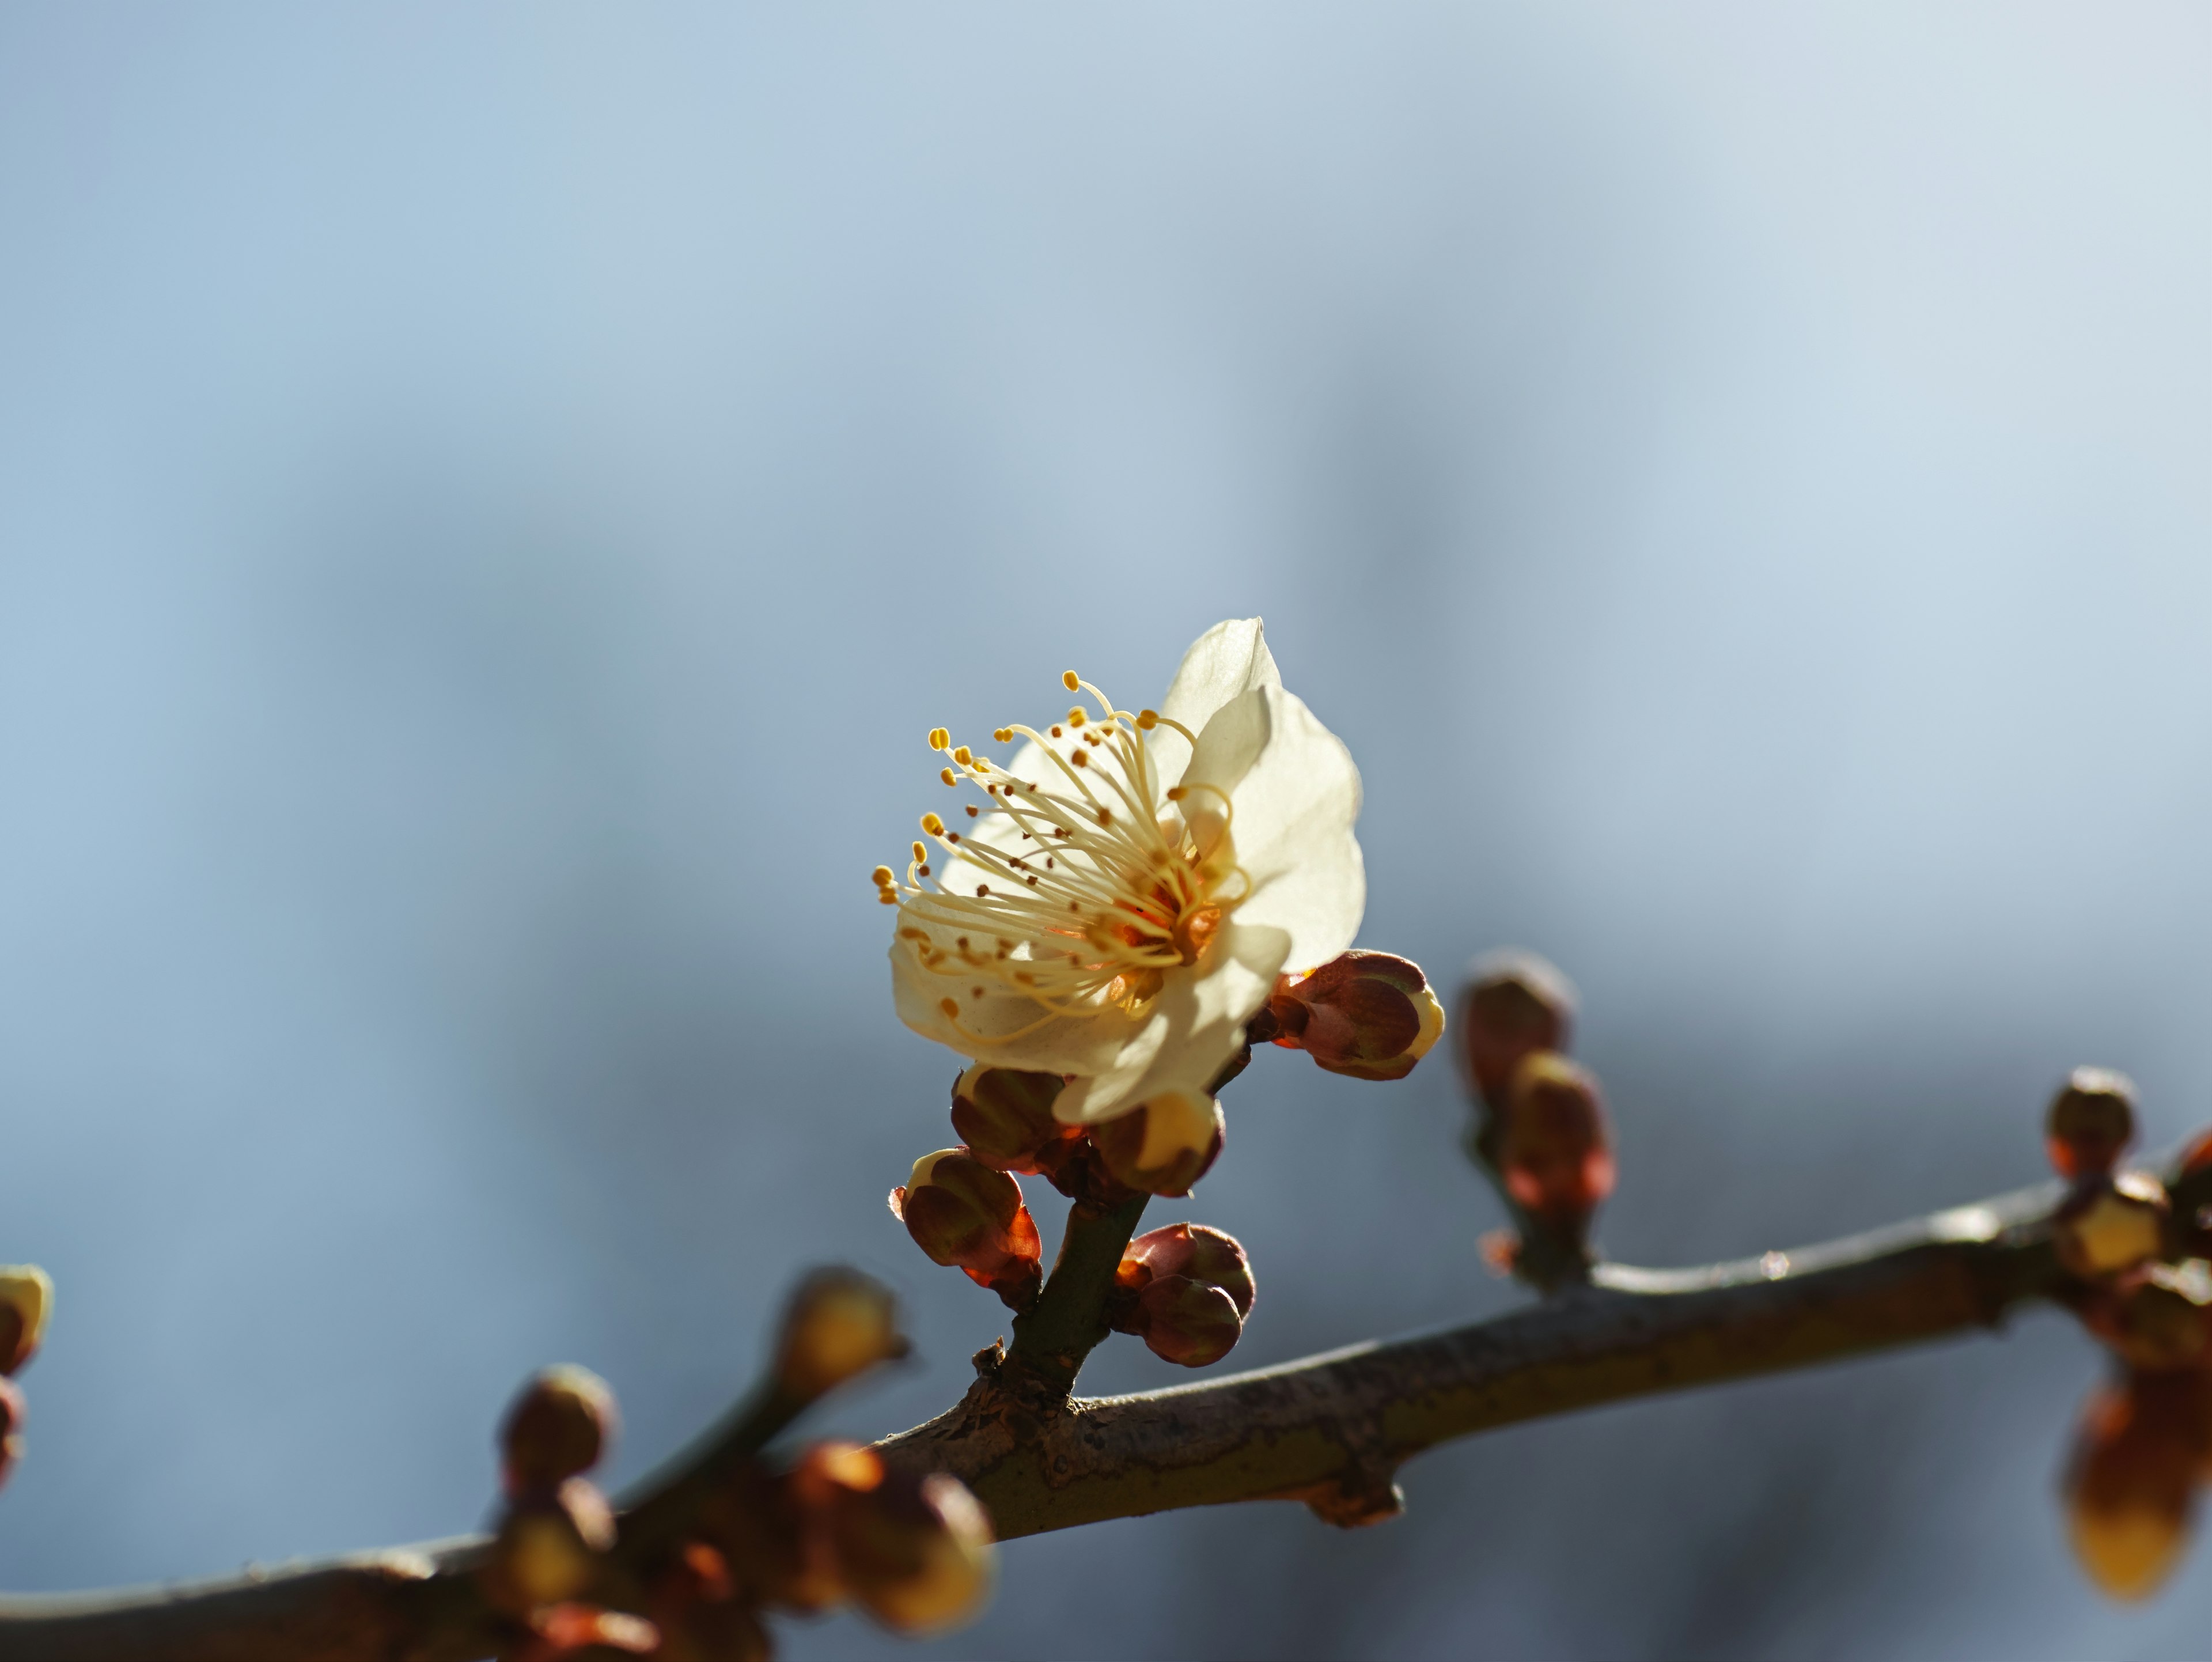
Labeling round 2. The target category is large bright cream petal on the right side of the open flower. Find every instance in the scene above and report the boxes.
[1183,686,1367,970]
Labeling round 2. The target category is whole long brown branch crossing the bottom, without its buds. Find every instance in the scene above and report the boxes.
[0,1184,2064,1662]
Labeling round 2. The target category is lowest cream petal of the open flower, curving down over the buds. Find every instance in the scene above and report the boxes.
[1053,912,1290,1125]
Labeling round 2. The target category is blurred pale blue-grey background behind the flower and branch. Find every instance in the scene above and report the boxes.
[0,0,2212,1657]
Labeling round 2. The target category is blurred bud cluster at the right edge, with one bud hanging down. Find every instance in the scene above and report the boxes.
[2044,1067,2212,1598]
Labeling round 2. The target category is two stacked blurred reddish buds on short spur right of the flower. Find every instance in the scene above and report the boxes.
[1458,952,1615,1286]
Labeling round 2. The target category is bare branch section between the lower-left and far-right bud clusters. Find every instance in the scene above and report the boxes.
[882,1184,2062,1538]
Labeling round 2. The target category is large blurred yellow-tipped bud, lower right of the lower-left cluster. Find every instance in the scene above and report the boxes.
[790,1443,995,1636]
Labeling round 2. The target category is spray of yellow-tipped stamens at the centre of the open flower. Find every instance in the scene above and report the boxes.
[876,671,1252,1042]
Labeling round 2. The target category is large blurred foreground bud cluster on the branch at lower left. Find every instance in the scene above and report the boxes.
[478,1270,995,1662]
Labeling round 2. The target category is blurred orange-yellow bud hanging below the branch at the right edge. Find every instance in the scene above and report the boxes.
[2066,1372,2205,1598]
